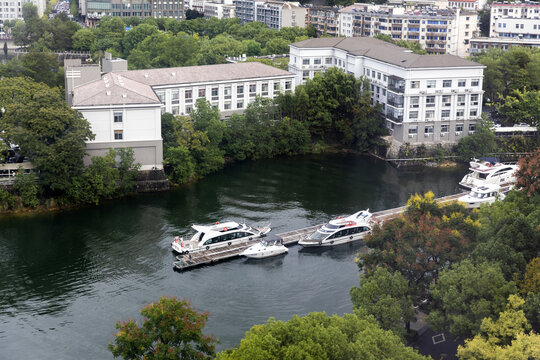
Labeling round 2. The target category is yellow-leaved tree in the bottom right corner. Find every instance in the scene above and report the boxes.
[457,295,540,360]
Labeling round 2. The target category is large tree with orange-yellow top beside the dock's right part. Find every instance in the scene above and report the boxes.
[358,192,480,305]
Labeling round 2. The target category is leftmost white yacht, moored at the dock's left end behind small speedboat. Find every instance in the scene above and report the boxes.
[171,221,271,254]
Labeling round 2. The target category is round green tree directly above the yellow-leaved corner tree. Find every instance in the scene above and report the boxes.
[427,260,517,337]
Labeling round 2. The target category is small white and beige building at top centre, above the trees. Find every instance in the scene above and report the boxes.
[255,0,306,30]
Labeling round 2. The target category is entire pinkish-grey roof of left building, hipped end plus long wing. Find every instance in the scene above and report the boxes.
[73,62,294,107]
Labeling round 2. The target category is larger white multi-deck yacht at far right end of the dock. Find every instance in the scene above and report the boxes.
[459,158,519,190]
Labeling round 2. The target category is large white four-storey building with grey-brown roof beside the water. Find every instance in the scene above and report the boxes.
[289,37,484,144]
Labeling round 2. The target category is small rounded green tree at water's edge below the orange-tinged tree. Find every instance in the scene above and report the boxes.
[351,268,414,337]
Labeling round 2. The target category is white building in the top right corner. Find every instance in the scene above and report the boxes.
[489,2,540,39]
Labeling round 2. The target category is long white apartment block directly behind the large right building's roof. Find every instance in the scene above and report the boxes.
[339,4,478,57]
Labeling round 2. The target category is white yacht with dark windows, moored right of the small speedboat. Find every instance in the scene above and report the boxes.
[298,209,372,247]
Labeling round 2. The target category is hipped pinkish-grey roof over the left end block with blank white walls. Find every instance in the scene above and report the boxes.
[73,73,161,106]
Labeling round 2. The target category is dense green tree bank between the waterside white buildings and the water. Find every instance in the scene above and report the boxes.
[162,69,385,184]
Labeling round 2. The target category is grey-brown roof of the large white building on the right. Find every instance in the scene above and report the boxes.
[291,37,483,68]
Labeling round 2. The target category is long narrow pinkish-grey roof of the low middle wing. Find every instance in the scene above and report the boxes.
[117,62,294,86]
